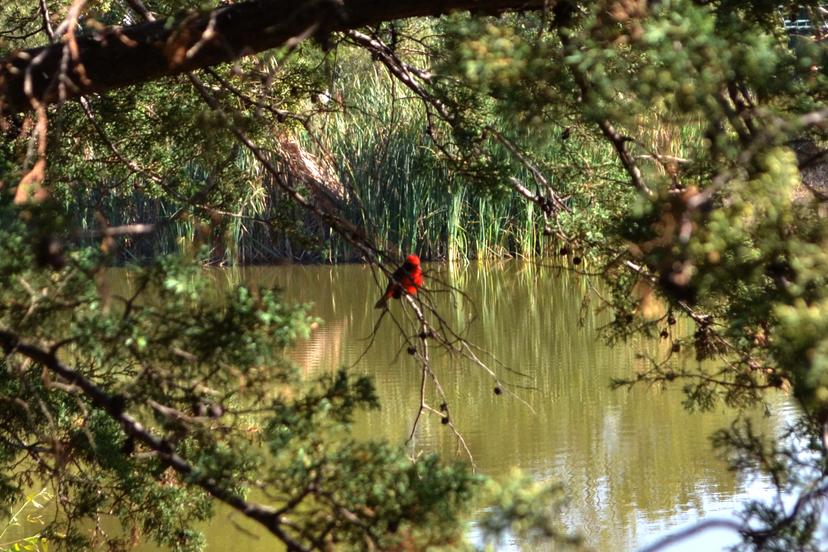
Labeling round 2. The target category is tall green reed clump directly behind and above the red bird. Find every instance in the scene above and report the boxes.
[322,50,556,259]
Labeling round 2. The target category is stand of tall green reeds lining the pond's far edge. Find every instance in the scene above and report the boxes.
[65,45,701,264]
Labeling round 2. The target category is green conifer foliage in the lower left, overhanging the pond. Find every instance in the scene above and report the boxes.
[0,189,576,550]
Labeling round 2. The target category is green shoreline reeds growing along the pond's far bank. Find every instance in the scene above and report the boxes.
[60,42,600,266]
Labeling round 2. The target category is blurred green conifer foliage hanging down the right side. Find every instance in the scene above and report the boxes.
[426,0,828,548]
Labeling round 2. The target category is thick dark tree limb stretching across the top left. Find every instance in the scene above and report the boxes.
[0,0,554,114]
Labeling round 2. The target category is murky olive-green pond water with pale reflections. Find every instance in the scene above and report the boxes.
[157,262,795,552]
